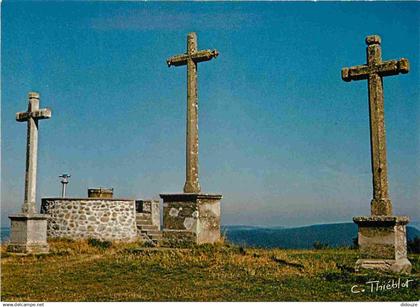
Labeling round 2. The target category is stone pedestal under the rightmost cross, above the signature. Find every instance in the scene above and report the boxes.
[353,216,411,273]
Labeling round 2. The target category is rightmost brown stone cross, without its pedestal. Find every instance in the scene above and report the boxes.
[341,35,409,215]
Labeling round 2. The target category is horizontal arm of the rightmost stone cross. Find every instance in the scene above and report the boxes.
[341,58,410,82]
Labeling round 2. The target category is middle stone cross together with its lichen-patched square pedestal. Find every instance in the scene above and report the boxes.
[160,33,222,244]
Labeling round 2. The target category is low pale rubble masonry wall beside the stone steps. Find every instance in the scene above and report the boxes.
[41,198,137,241]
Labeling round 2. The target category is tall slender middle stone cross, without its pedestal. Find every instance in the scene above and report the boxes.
[166,32,219,193]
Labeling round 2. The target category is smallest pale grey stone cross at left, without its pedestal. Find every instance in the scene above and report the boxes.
[16,92,51,214]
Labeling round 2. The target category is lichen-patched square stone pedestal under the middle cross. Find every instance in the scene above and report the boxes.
[160,193,222,244]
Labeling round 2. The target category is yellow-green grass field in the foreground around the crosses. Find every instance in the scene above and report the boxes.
[1,240,420,301]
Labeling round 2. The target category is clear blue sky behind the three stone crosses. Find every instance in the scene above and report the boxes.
[1,1,420,226]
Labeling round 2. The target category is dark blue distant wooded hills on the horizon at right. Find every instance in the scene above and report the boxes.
[222,223,420,249]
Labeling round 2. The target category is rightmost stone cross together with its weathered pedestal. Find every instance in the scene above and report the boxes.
[341,35,411,272]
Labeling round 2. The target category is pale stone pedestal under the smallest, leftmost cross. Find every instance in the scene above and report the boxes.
[7,213,49,254]
